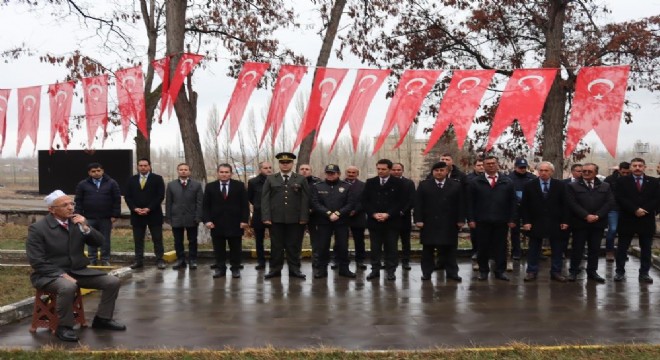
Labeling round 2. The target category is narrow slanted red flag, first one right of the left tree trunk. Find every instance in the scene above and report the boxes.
[218,62,270,142]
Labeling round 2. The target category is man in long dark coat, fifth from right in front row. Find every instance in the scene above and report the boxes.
[414,161,465,282]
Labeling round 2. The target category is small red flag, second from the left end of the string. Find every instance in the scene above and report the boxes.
[16,86,41,155]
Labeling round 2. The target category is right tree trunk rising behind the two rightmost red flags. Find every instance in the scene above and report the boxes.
[542,0,566,179]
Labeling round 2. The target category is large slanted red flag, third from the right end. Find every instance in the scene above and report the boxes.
[424,70,495,155]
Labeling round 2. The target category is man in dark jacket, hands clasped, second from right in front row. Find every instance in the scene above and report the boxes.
[568,163,614,283]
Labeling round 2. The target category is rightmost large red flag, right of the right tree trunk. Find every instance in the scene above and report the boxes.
[564,65,630,157]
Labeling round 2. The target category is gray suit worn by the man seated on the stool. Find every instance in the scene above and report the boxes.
[26,214,119,326]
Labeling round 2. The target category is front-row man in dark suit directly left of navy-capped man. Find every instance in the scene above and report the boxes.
[467,155,518,281]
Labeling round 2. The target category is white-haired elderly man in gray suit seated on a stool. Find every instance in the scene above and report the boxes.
[26,190,126,341]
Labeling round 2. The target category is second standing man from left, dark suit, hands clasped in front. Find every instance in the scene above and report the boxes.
[124,159,165,270]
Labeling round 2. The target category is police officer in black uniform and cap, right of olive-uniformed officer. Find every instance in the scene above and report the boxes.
[311,164,357,279]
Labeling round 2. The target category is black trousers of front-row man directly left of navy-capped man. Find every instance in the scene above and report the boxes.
[476,222,509,274]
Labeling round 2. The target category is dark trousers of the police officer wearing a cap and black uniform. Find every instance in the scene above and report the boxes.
[316,223,349,269]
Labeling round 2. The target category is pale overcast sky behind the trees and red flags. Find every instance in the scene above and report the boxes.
[0,0,660,157]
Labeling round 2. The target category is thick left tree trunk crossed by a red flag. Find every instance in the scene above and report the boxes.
[166,0,206,183]
